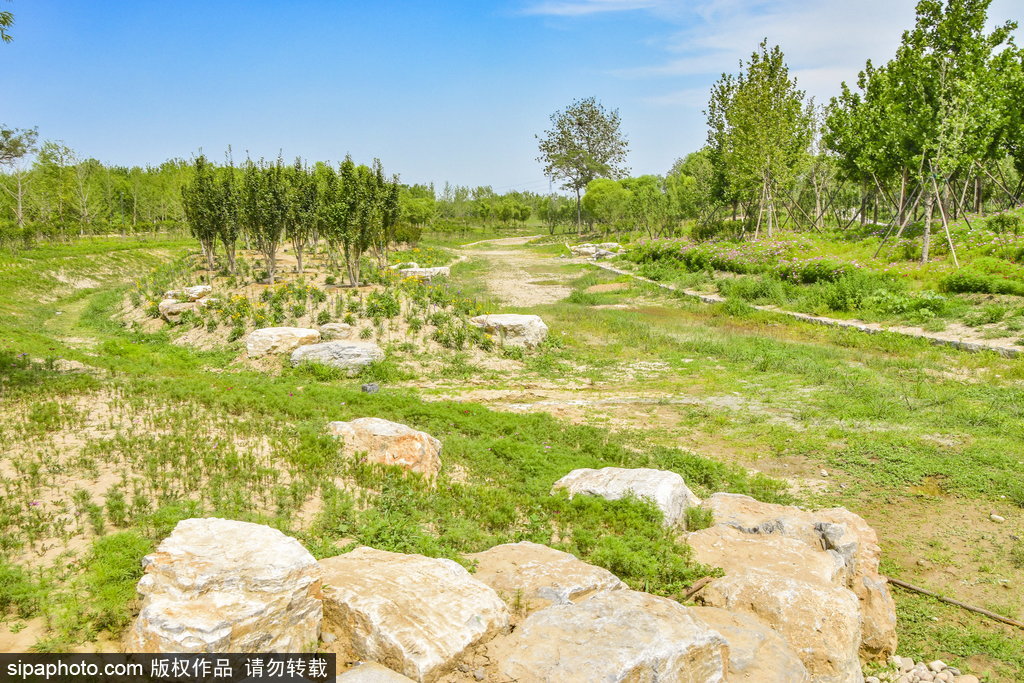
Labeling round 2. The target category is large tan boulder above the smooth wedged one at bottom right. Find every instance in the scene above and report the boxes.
[699,567,863,683]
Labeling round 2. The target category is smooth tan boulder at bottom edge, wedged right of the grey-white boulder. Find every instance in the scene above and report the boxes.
[690,607,811,683]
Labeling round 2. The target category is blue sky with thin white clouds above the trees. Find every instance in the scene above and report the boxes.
[0,0,1024,193]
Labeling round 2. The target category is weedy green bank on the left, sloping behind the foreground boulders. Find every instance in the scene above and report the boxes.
[0,242,778,650]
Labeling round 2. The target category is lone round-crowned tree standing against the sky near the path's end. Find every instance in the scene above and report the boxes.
[537,97,629,229]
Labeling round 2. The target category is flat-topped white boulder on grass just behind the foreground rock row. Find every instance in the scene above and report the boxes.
[552,467,700,526]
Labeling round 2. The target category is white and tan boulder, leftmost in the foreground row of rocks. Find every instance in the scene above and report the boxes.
[125,518,323,652]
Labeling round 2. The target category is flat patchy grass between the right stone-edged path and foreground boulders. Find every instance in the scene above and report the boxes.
[446,242,1024,680]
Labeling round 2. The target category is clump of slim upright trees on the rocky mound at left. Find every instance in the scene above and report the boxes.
[181,155,401,285]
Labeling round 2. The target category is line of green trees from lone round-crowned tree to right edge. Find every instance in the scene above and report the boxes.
[561,0,1024,253]
